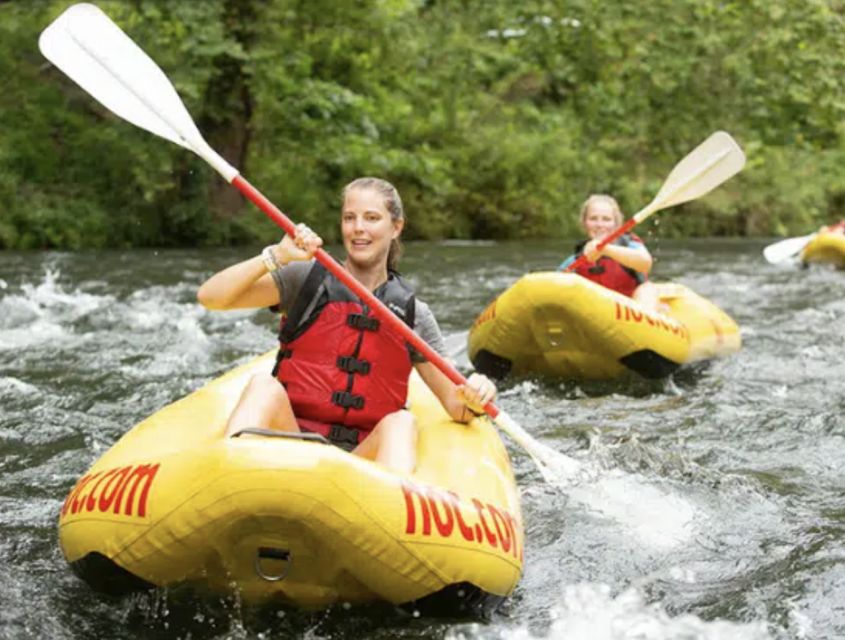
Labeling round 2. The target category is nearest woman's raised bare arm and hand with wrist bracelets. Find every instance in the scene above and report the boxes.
[197,225,323,311]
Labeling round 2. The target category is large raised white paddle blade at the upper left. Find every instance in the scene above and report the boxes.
[38,3,238,182]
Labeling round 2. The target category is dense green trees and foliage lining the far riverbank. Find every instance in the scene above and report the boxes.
[0,0,845,249]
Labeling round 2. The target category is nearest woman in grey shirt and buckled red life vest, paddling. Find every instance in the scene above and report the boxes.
[197,178,496,472]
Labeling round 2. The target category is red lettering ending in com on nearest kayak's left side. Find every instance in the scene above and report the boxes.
[61,463,160,518]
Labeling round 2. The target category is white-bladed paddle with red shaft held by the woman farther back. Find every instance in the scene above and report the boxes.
[566,131,745,271]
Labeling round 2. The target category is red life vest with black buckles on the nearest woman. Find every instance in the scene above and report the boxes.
[273,262,416,448]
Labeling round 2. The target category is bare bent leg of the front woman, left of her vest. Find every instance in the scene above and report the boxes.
[226,373,299,437]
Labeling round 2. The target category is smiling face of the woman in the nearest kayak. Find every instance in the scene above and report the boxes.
[340,188,404,268]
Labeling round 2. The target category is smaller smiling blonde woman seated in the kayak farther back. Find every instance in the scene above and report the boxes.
[558,195,659,311]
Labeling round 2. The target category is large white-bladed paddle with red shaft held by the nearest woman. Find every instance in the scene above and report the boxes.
[38,3,580,483]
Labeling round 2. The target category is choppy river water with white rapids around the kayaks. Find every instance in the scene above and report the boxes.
[0,240,845,640]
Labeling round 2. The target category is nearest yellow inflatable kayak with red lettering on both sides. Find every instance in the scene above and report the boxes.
[59,353,523,614]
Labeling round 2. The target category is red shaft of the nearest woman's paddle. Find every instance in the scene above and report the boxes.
[227,175,499,418]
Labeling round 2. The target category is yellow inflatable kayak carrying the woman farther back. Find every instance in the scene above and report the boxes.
[468,272,740,380]
